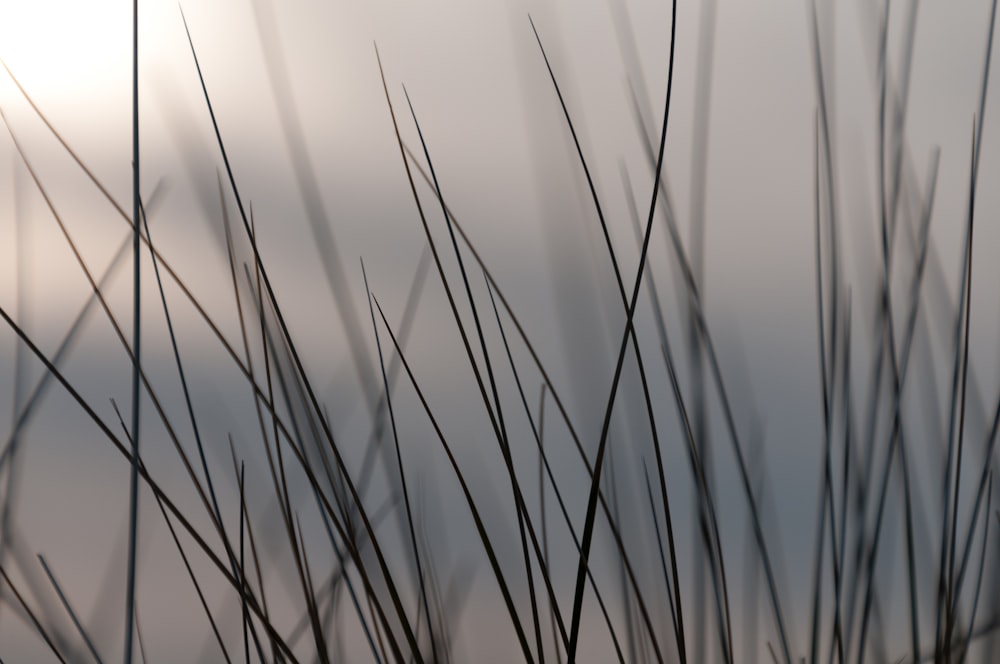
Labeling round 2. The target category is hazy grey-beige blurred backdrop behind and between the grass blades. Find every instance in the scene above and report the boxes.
[0,0,1000,662]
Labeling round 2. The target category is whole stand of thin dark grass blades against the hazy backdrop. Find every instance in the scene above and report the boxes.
[0,0,1000,664]
